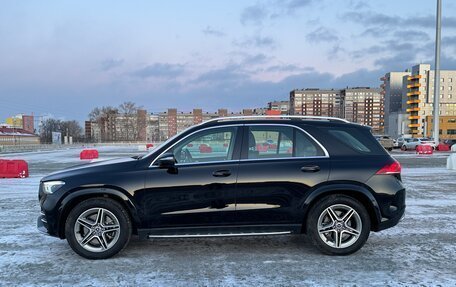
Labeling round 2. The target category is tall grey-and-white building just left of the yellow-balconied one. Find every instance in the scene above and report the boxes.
[380,72,410,137]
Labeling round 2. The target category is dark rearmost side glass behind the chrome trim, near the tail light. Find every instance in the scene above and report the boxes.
[327,127,385,154]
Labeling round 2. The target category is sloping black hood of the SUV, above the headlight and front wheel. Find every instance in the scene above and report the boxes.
[41,158,138,181]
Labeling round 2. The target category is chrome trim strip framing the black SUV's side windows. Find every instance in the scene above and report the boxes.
[149,123,329,168]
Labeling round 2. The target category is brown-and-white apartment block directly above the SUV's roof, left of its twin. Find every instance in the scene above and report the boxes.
[290,89,343,118]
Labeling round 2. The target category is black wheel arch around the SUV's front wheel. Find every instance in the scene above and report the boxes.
[58,187,140,239]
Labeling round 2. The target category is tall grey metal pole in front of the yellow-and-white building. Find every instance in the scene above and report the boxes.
[433,0,442,145]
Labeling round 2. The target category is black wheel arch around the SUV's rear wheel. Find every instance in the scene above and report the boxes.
[301,182,382,233]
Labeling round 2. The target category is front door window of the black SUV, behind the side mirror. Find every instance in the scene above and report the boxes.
[173,127,237,163]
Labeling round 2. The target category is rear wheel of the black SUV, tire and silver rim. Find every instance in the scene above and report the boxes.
[307,194,371,255]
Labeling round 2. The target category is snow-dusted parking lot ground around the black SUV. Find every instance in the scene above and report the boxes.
[0,146,456,286]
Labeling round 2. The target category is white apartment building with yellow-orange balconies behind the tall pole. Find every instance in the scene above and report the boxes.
[406,64,456,139]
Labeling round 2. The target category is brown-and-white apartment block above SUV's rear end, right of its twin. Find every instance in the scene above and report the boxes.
[342,87,385,133]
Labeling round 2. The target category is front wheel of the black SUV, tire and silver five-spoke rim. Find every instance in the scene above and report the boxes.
[65,198,132,259]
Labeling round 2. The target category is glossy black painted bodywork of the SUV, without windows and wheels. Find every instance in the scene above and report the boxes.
[38,120,405,241]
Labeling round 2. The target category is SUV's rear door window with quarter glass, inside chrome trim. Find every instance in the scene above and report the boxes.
[248,126,325,159]
